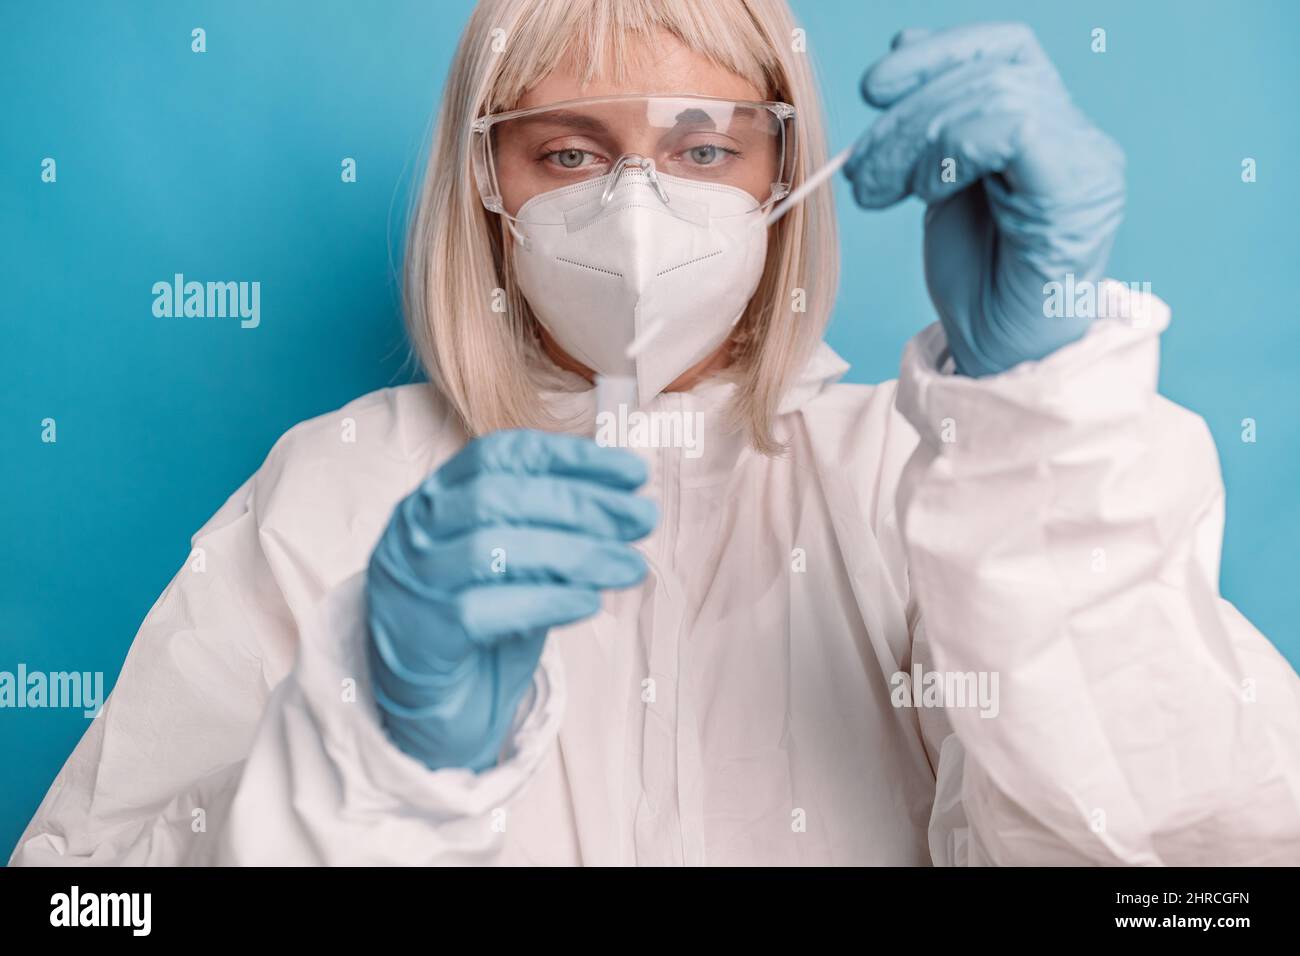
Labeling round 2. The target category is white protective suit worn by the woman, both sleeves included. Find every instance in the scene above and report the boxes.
[13,286,1300,865]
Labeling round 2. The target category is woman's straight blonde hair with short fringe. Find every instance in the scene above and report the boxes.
[403,0,839,454]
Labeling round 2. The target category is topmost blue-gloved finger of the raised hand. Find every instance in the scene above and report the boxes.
[862,23,1054,109]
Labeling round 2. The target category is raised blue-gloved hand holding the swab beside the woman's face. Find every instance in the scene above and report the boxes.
[845,23,1125,376]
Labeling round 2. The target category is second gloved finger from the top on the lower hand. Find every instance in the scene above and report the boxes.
[412,472,659,541]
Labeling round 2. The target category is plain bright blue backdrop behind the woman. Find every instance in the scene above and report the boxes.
[0,0,1300,855]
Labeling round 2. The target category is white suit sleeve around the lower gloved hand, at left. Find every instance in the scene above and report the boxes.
[10,451,563,865]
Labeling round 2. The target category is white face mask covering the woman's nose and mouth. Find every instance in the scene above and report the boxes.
[512,166,767,405]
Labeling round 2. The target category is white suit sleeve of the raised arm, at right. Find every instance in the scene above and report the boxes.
[898,285,1300,865]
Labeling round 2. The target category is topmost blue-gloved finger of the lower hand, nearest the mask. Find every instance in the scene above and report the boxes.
[425,429,646,490]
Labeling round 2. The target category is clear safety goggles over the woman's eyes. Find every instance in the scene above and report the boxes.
[472,95,794,225]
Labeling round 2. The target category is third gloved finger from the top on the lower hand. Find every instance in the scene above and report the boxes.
[390,524,646,601]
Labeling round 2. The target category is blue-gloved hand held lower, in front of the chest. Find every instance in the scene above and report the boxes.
[367,431,658,771]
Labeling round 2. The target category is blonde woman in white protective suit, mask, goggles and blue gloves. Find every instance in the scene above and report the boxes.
[14,0,1300,864]
